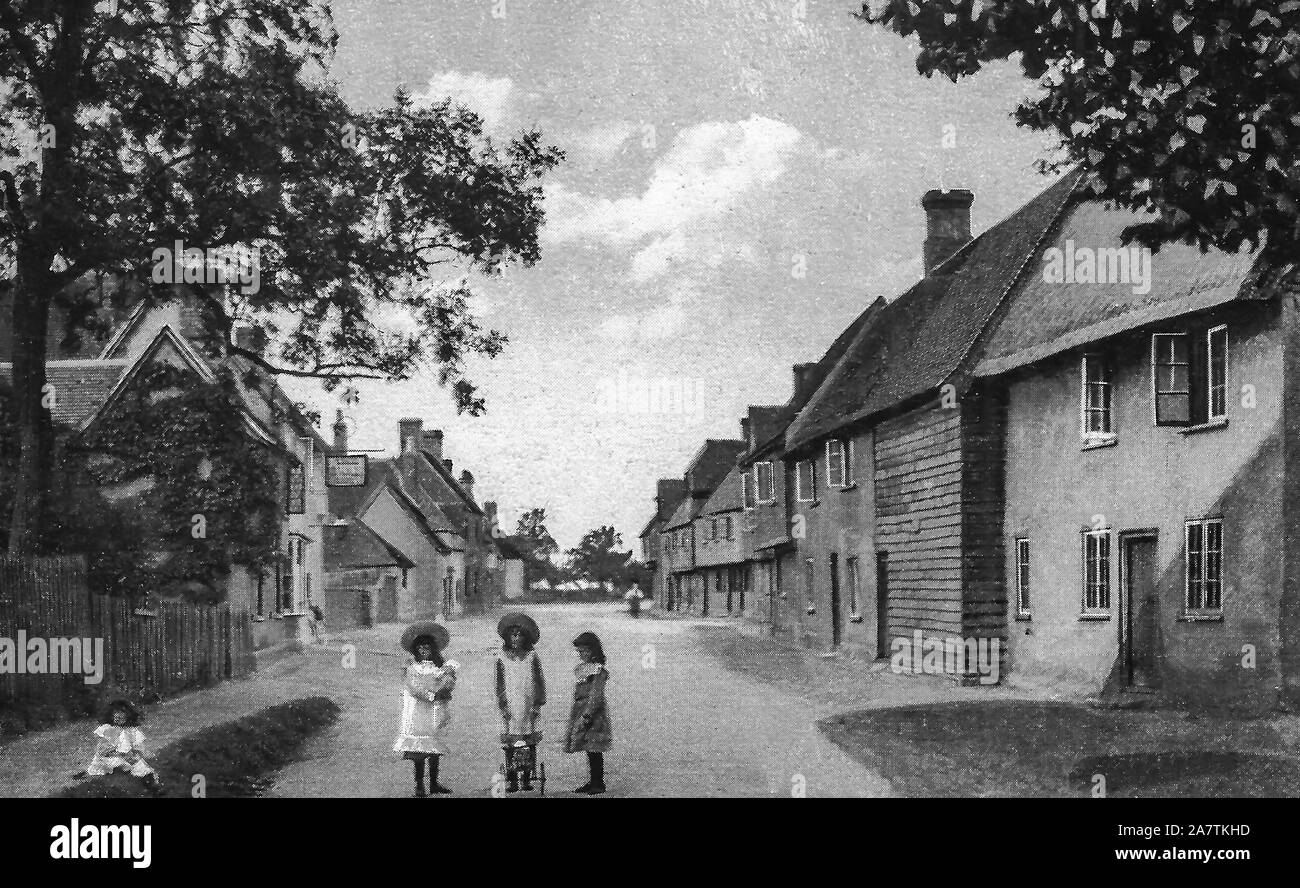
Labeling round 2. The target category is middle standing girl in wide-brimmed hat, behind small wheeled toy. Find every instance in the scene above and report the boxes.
[497,614,546,792]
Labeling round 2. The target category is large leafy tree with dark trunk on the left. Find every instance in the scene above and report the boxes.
[0,0,560,554]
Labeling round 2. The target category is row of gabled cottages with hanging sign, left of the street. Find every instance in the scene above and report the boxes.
[0,293,524,647]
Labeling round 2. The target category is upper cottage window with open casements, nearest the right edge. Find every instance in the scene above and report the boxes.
[1151,325,1227,425]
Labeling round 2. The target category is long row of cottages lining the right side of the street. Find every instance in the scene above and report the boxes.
[641,170,1300,707]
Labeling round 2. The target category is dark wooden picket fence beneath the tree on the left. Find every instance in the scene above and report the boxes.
[0,558,255,706]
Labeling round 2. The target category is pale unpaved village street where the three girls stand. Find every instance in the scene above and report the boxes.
[267,605,889,797]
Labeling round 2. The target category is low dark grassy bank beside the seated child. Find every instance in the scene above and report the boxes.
[53,697,339,798]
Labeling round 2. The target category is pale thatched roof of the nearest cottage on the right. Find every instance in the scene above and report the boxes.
[975,200,1269,376]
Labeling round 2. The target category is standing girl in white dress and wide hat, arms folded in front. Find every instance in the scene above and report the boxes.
[393,623,460,797]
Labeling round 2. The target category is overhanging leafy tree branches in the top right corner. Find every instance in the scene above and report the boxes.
[861,0,1300,261]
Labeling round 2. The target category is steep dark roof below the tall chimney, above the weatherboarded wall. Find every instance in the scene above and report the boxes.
[785,170,1083,450]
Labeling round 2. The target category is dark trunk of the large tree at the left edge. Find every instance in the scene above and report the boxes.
[9,250,59,556]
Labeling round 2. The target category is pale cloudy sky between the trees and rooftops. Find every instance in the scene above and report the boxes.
[286,0,1052,549]
